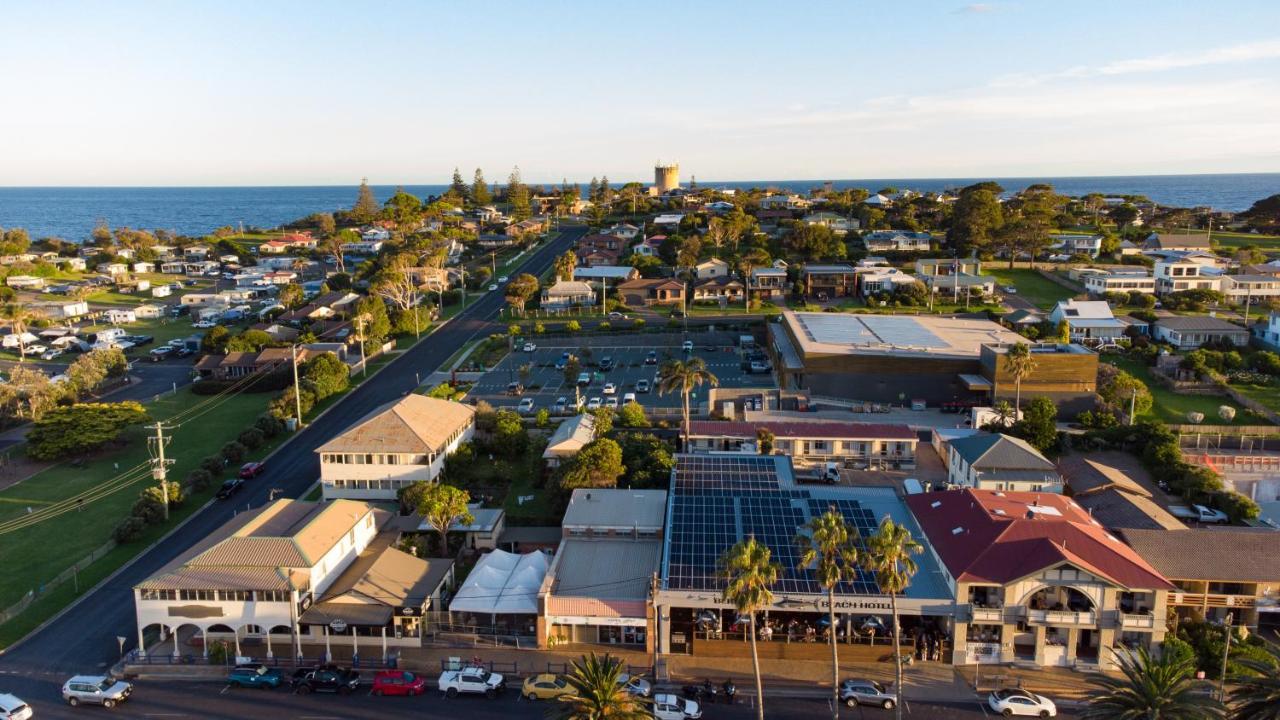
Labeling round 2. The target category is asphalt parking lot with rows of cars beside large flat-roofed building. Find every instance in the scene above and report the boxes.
[471,332,774,413]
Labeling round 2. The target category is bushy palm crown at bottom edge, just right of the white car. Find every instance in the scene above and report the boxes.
[1080,647,1223,720]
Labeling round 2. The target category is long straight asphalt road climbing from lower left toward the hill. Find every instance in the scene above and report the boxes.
[0,228,586,696]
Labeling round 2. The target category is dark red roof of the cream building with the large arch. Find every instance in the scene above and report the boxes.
[906,488,1174,589]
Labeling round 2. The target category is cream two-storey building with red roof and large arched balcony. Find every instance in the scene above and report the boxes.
[906,488,1175,670]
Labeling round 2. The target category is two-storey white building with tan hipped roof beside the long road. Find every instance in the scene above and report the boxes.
[316,393,475,500]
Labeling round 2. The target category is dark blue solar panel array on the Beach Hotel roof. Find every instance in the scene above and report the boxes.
[667,456,879,594]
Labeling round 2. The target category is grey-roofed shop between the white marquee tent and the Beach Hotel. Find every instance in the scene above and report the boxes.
[538,488,667,652]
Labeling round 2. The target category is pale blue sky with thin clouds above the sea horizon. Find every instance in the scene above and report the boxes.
[0,0,1280,186]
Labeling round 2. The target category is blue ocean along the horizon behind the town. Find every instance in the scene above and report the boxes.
[0,173,1280,241]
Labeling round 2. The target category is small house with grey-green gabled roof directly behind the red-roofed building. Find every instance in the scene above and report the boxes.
[947,433,1062,493]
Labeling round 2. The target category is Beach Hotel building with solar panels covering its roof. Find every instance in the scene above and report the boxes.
[654,455,952,660]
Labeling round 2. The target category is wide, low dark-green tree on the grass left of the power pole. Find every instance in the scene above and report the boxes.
[27,401,147,460]
